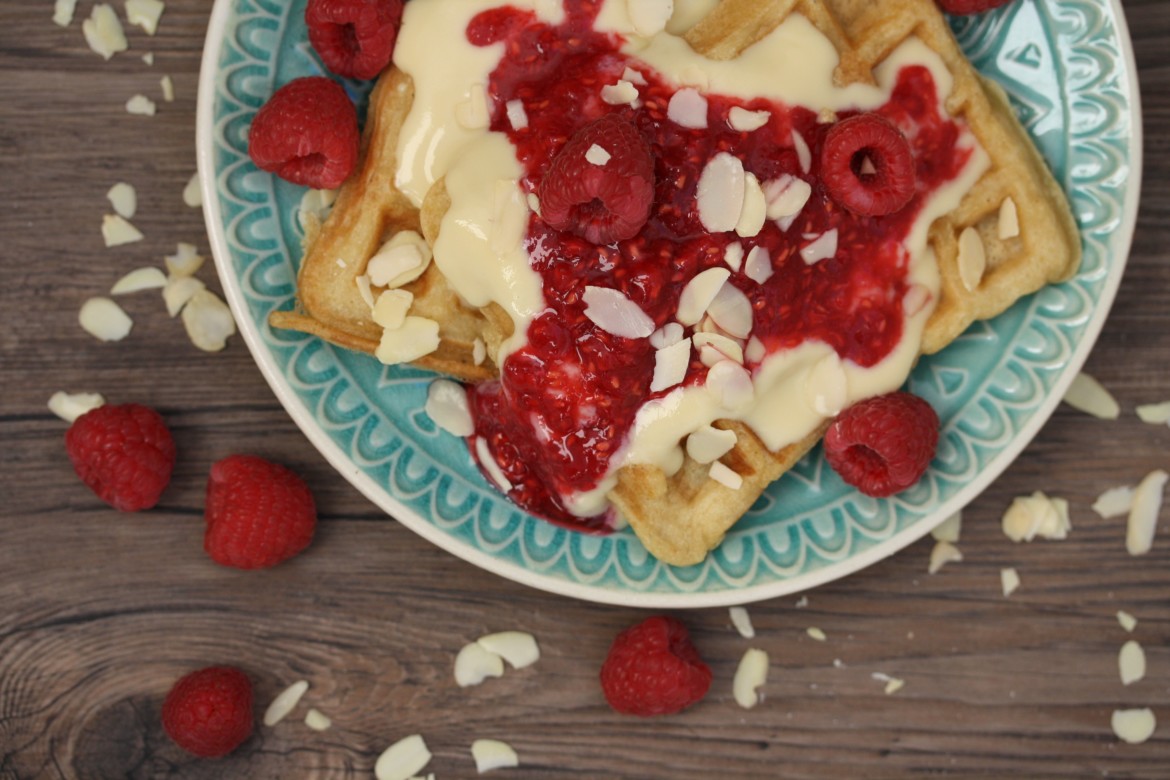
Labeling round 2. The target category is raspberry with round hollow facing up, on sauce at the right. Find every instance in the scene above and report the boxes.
[820,113,915,216]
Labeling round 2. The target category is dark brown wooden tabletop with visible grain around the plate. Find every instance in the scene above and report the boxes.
[0,0,1170,780]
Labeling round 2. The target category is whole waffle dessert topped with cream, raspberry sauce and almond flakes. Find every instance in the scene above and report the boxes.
[265,0,1080,565]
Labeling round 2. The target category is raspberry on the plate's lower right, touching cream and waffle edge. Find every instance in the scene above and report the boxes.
[825,393,938,498]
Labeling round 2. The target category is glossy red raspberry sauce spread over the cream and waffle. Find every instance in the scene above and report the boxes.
[467,0,970,531]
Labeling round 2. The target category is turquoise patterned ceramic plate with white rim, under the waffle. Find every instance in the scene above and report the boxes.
[198,0,1141,607]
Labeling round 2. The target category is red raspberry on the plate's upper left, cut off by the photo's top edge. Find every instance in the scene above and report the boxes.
[304,0,402,78]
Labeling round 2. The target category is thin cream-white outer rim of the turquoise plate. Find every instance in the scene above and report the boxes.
[195,0,1144,609]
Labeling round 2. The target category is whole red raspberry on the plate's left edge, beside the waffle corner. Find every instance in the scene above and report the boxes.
[248,76,360,189]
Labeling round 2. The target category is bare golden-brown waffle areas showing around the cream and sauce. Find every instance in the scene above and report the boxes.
[265,0,1080,565]
